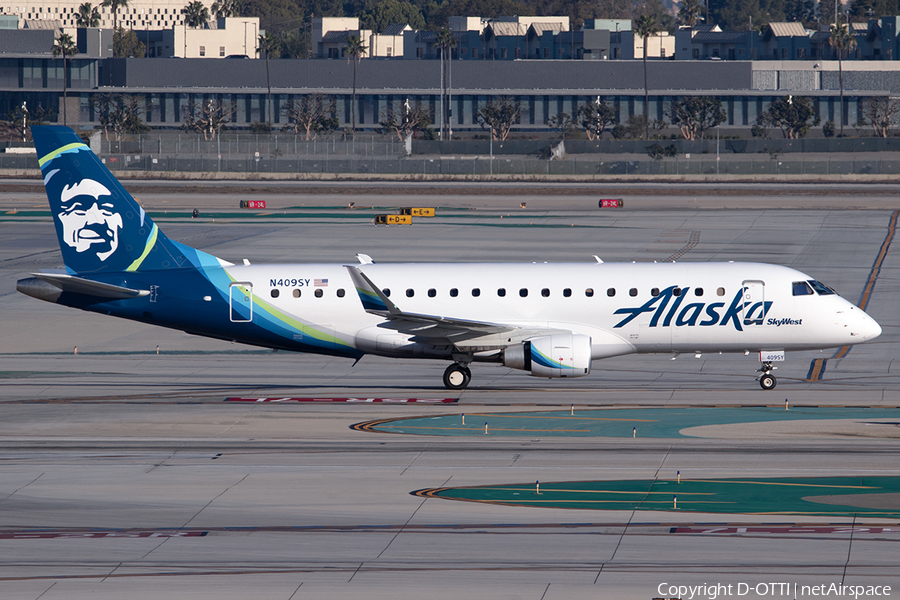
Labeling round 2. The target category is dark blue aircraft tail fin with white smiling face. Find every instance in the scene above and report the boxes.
[31,125,218,274]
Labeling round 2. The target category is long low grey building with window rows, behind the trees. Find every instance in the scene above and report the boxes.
[0,58,900,132]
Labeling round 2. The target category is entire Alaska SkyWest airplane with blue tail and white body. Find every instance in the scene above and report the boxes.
[16,126,881,390]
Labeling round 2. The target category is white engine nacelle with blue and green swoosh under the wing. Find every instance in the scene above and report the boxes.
[503,333,591,377]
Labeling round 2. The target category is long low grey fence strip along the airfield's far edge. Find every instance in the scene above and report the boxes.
[0,154,900,176]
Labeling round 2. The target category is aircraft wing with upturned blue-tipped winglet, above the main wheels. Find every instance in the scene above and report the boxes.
[346,265,570,351]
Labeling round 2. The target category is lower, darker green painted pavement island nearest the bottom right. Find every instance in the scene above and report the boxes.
[413,477,900,518]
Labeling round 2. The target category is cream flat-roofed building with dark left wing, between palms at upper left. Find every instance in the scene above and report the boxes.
[138,17,260,58]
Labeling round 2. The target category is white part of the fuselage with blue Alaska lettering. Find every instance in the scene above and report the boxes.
[226,263,881,359]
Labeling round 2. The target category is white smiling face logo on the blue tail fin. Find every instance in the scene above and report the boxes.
[58,179,122,261]
